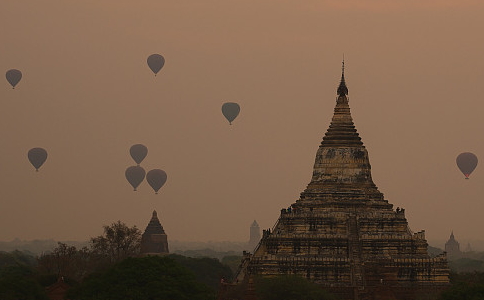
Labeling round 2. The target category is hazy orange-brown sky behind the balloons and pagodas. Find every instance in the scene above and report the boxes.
[0,0,484,246]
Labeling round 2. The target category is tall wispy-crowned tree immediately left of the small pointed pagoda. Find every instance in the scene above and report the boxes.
[91,221,141,263]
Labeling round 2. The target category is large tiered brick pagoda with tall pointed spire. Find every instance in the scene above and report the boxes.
[235,62,449,300]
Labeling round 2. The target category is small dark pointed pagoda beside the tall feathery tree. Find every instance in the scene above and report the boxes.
[140,210,169,255]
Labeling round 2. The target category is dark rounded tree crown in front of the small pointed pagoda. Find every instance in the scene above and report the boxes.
[68,256,215,300]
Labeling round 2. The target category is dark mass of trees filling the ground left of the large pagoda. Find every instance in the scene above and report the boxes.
[0,221,232,300]
